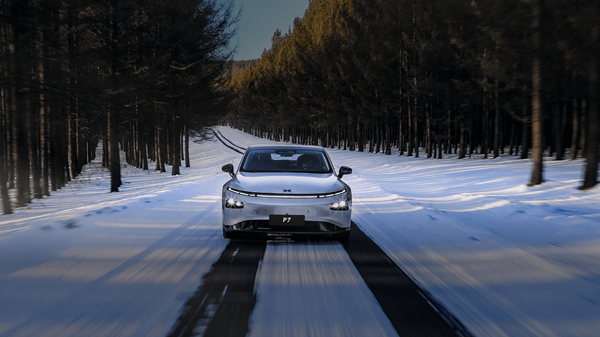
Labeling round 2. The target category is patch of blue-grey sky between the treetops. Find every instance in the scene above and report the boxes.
[232,0,308,61]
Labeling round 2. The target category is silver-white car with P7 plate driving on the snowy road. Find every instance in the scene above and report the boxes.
[222,145,352,242]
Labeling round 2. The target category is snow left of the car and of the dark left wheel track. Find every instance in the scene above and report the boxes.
[0,137,239,337]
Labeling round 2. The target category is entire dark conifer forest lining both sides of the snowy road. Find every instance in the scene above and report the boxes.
[0,0,600,213]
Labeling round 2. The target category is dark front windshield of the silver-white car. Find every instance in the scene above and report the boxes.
[241,149,333,173]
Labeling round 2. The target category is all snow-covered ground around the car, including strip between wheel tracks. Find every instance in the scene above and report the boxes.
[0,127,600,336]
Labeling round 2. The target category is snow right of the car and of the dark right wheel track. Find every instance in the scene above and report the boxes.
[219,127,600,336]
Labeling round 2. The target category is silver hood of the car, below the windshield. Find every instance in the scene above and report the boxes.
[227,172,348,194]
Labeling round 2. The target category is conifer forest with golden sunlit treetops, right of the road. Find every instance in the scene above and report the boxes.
[227,0,600,189]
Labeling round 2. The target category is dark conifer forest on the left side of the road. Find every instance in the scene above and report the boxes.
[0,0,237,213]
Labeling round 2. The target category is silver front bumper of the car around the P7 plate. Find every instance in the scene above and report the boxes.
[222,189,352,234]
